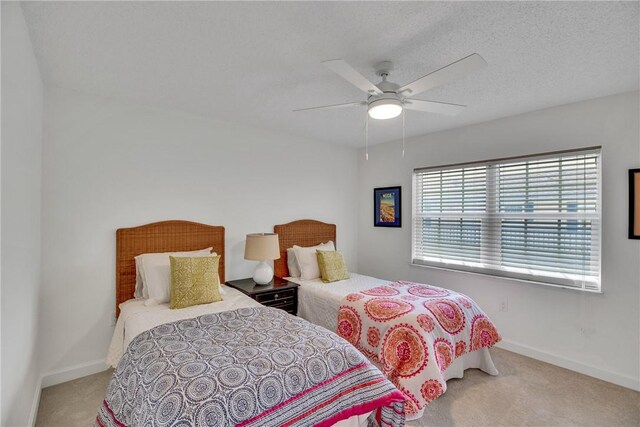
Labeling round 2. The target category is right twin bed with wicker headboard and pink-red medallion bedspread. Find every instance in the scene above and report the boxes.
[274,220,500,420]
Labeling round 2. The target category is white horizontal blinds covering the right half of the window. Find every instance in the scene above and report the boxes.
[497,153,600,287]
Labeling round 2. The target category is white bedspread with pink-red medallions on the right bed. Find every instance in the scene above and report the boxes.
[337,281,501,416]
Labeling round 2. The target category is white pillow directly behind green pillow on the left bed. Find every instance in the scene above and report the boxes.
[134,248,216,303]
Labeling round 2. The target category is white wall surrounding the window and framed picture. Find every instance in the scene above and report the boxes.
[358,92,640,389]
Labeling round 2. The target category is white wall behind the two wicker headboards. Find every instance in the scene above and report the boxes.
[40,89,357,378]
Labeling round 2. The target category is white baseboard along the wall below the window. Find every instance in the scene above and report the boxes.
[496,339,640,391]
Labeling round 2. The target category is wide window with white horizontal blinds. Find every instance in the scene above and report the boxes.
[412,148,600,291]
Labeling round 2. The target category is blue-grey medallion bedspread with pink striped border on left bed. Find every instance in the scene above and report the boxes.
[96,307,404,427]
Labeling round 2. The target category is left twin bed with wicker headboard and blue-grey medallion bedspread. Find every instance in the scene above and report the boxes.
[102,221,404,427]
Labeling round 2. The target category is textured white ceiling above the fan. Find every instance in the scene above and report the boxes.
[22,2,640,146]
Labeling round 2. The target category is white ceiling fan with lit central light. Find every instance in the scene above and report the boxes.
[294,53,487,120]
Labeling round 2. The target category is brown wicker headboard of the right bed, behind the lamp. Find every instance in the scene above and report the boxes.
[273,219,336,277]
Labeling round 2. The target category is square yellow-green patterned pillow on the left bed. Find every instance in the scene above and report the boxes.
[169,255,222,308]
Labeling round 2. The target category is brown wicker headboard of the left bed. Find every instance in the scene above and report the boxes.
[116,221,224,316]
